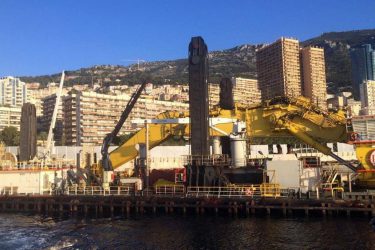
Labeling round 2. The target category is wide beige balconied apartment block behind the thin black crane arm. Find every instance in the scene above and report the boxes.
[63,91,189,146]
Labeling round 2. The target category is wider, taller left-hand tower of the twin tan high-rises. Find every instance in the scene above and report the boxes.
[256,37,302,101]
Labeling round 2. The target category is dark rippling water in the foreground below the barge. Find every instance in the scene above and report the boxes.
[0,214,375,249]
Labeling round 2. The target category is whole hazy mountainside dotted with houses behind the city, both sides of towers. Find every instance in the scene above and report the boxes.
[21,29,375,93]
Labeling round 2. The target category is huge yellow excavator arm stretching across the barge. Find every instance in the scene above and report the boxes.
[103,97,375,186]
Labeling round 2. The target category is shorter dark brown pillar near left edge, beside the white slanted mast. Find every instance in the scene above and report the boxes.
[20,103,36,161]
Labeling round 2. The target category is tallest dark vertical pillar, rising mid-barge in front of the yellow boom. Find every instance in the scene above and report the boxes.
[189,36,210,156]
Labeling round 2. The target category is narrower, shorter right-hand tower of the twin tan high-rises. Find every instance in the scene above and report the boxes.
[301,47,327,109]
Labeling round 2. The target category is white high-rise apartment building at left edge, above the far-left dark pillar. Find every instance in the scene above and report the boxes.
[0,76,27,107]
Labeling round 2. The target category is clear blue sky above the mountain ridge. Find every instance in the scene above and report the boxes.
[0,0,375,76]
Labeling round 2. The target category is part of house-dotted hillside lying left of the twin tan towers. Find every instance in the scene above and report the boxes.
[21,44,261,86]
